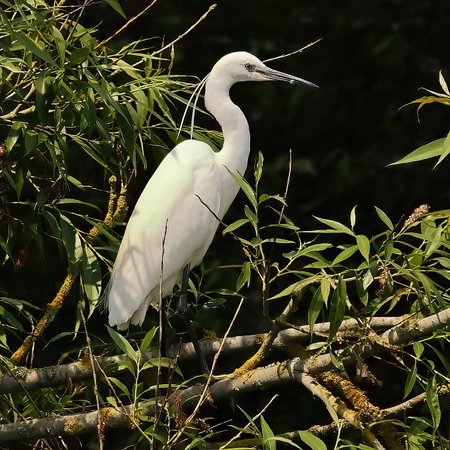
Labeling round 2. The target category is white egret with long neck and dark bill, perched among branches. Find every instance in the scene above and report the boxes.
[107,52,317,329]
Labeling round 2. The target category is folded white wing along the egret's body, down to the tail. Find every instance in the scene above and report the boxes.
[108,141,220,325]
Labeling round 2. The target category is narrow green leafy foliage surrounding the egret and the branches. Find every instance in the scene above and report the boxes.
[0,0,450,450]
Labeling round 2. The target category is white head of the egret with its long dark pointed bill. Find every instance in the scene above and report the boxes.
[210,52,318,87]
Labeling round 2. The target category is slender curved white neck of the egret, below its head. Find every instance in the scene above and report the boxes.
[205,74,250,175]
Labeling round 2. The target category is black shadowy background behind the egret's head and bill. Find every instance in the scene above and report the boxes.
[91,0,450,234]
